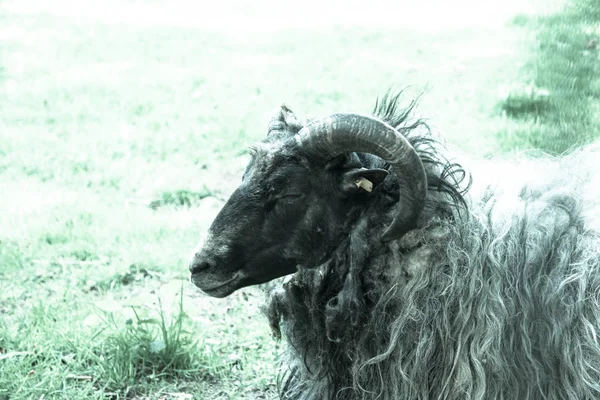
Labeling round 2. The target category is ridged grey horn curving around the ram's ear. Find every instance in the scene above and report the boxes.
[296,114,427,241]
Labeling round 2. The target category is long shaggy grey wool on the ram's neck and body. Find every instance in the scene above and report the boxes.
[266,96,600,400]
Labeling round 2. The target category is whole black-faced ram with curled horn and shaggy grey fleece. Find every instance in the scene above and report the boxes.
[190,94,600,400]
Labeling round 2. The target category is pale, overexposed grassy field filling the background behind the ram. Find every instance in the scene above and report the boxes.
[0,0,600,400]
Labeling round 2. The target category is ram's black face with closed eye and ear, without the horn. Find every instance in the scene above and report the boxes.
[190,146,387,297]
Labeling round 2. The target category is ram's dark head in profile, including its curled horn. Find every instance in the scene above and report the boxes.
[189,105,427,297]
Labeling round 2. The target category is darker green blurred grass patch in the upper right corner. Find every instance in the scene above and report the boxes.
[498,0,600,154]
